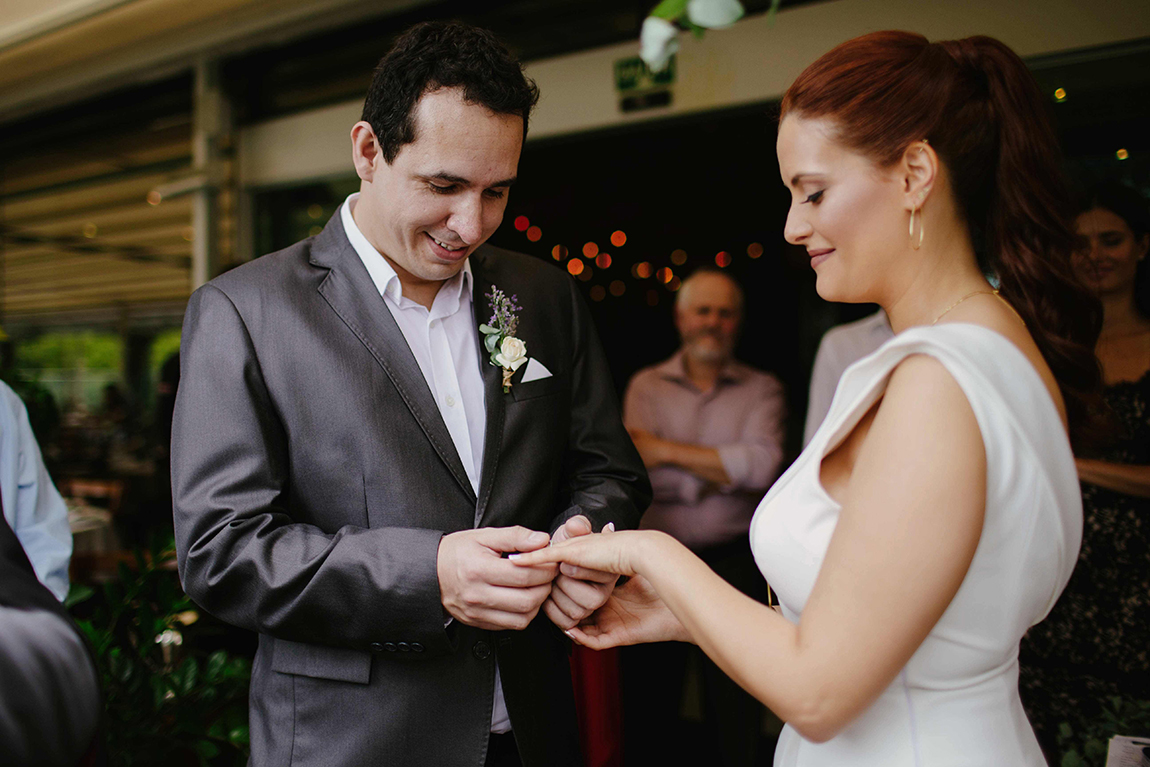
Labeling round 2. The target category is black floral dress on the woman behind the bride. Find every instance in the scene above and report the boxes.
[1020,371,1150,764]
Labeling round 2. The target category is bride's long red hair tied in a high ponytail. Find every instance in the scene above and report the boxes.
[782,32,1102,450]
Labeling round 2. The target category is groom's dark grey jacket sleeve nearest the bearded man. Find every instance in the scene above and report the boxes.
[551,279,651,531]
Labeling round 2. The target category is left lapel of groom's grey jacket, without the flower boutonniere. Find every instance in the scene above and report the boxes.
[312,210,476,503]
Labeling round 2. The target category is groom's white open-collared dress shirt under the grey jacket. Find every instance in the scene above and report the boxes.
[339,193,511,733]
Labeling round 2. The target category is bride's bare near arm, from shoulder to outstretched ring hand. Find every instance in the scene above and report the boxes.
[523,356,986,741]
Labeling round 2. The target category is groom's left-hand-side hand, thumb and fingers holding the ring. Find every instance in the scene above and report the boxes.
[436,527,558,631]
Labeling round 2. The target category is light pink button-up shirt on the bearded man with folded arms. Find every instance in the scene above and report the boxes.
[623,351,787,550]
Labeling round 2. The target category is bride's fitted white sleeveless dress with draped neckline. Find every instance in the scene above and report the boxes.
[751,323,1082,767]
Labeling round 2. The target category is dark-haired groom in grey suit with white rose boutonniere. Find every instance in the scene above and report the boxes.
[171,23,650,767]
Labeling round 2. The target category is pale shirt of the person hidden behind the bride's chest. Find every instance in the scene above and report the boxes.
[803,309,895,447]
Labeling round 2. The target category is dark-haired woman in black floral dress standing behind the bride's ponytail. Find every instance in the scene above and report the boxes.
[1020,183,1150,764]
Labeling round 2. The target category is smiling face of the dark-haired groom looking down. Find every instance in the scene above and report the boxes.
[354,89,523,290]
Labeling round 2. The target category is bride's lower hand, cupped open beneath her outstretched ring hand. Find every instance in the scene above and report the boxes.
[567,575,691,650]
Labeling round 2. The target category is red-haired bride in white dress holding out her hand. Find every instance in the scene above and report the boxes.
[515,32,1101,767]
